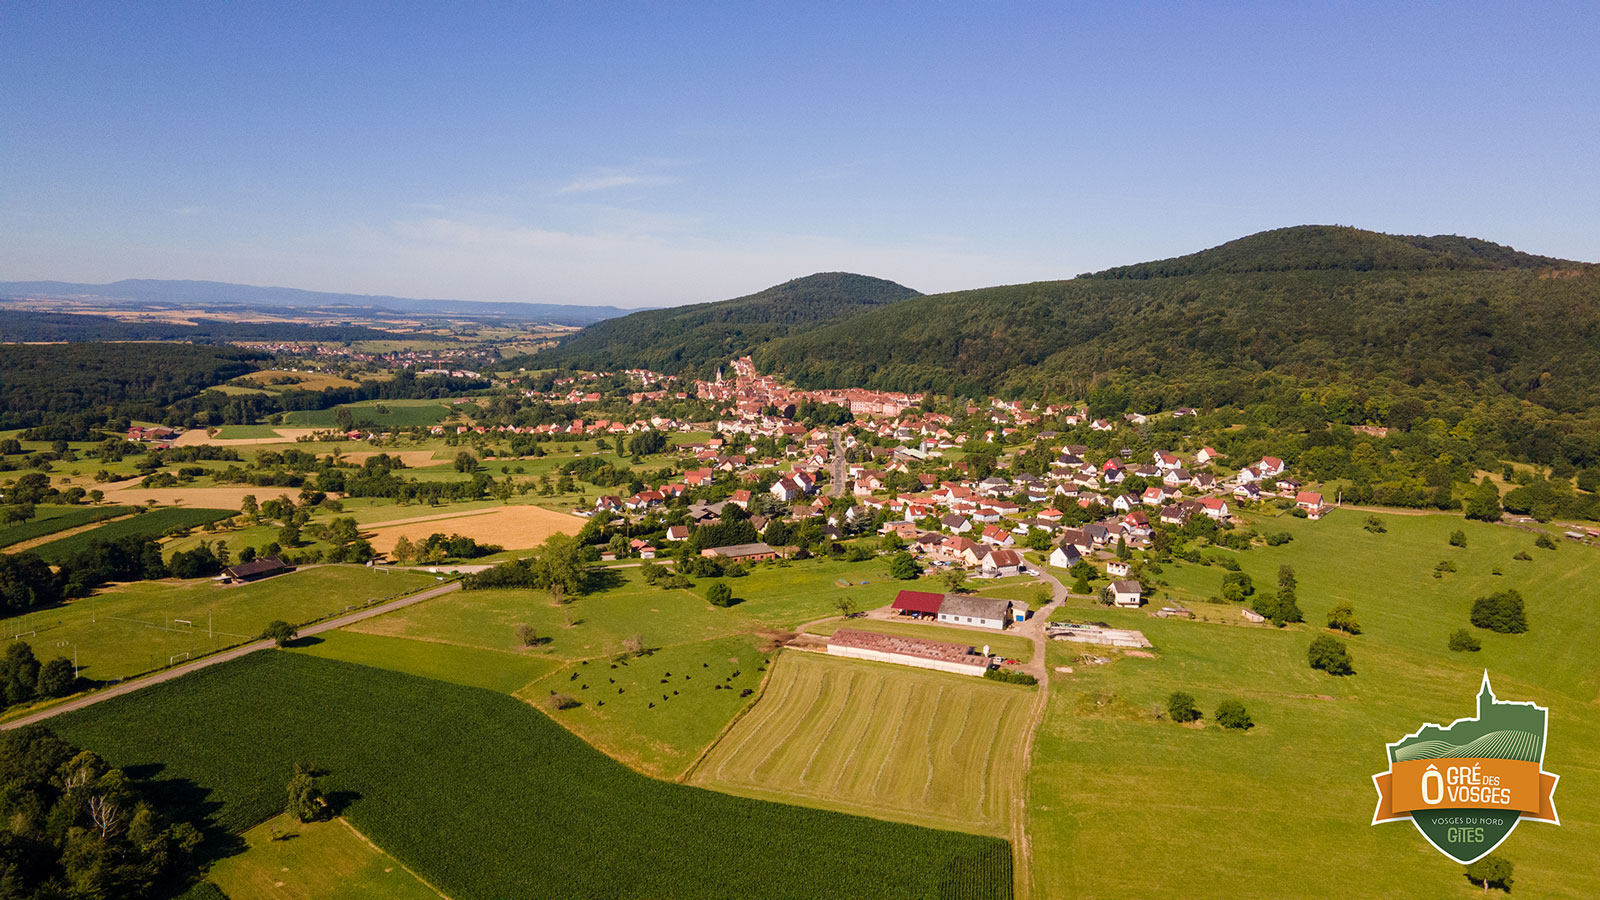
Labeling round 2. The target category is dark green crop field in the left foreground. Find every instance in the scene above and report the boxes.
[56,652,1011,900]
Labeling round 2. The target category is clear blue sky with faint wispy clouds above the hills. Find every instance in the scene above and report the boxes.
[0,2,1600,306]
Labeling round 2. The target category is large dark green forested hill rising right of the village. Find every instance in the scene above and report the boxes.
[757,229,1600,421]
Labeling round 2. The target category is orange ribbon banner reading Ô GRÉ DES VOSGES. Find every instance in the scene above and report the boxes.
[1373,759,1557,820]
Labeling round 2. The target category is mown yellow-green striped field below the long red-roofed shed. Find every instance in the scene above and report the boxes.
[691,650,1037,834]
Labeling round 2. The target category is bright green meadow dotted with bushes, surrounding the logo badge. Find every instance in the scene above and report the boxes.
[1029,509,1600,900]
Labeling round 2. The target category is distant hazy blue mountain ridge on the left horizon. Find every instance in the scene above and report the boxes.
[0,279,634,325]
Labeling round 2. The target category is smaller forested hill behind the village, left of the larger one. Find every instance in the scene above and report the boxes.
[524,272,920,373]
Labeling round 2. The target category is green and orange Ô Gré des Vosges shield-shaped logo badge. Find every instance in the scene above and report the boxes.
[1373,671,1562,863]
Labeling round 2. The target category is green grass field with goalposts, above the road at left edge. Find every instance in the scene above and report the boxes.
[0,565,437,681]
